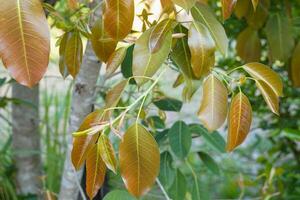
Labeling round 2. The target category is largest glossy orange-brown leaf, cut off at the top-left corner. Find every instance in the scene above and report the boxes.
[0,0,50,87]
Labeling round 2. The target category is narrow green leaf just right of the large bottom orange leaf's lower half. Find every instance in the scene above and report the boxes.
[159,151,176,189]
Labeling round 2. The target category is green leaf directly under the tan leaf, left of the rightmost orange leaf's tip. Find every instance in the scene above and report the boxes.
[189,124,226,153]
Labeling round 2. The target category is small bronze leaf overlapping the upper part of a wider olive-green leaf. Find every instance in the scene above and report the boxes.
[149,19,174,54]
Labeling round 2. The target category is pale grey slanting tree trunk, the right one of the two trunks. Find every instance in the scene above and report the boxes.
[59,0,101,200]
